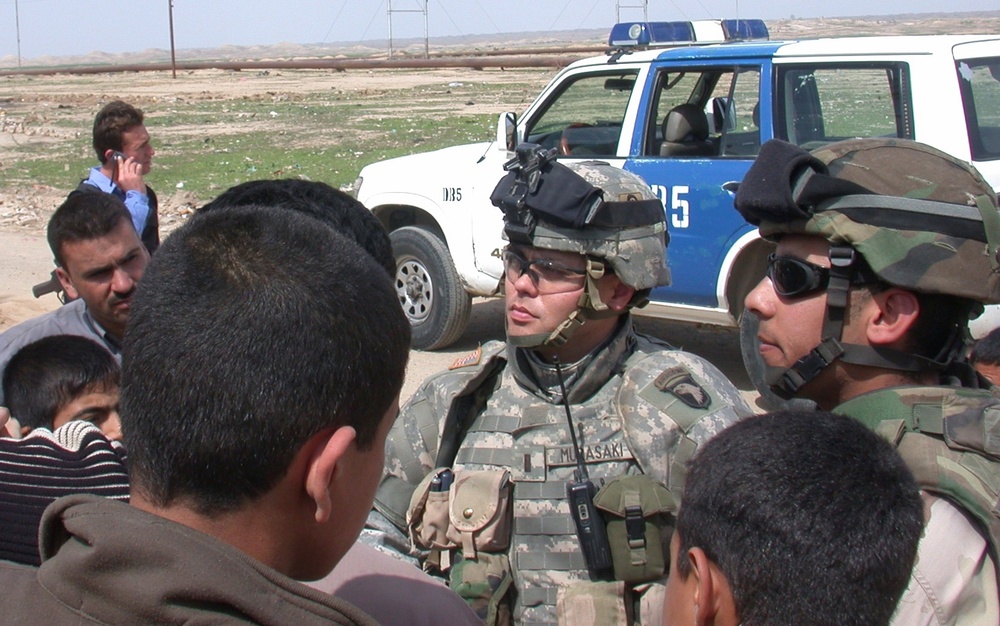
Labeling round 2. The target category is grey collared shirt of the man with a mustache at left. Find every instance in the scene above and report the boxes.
[0,300,122,405]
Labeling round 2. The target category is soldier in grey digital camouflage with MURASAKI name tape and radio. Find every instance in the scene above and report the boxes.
[369,144,751,626]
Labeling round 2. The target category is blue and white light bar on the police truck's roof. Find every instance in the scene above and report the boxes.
[608,19,768,48]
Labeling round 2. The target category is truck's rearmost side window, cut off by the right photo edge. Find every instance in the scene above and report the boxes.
[957,58,1000,161]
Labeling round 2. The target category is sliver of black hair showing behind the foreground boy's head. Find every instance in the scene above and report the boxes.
[201,178,396,276]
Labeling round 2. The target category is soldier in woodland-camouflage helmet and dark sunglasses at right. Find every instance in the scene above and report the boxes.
[736,139,1000,626]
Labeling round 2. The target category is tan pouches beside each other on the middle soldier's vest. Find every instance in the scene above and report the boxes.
[406,469,513,569]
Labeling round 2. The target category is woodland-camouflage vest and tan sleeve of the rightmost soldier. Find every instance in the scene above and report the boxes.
[834,386,1000,626]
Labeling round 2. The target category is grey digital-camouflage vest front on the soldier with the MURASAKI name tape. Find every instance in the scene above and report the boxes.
[455,369,638,626]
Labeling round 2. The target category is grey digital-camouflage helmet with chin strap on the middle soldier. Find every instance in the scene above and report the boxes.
[490,143,670,347]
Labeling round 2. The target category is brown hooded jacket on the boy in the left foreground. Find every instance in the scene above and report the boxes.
[0,495,377,626]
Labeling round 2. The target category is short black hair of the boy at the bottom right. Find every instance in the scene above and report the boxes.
[677,411,923,626]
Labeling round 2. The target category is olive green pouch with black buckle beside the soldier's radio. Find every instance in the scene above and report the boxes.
[594,474,677,583]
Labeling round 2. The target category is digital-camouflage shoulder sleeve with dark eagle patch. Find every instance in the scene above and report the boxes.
[616,350,753,493]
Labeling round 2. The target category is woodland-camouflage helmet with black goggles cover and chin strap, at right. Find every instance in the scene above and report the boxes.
[736,138,1000,397]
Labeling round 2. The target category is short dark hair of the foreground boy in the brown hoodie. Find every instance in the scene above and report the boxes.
[119,207,410,516]
